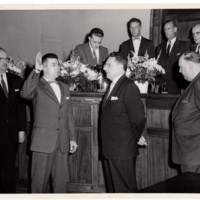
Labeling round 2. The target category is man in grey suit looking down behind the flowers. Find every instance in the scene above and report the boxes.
[74,28,108,67]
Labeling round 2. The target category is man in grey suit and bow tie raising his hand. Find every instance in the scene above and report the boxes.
[21,53,77,193]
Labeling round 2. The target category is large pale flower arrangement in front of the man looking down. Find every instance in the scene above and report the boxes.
[59,55,100,92]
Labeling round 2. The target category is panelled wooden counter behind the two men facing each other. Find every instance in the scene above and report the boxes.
[67,92,178,192]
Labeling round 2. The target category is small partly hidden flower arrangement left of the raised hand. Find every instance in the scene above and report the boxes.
[7,56,26,76]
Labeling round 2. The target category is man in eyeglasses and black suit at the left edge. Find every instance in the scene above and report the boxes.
[0,48,26,193]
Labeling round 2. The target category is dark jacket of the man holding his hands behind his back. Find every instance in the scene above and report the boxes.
[101,75,145,160]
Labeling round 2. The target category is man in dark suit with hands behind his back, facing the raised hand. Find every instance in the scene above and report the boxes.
[101,52,146,193]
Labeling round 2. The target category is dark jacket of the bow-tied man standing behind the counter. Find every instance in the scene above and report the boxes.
[119,37,155,58]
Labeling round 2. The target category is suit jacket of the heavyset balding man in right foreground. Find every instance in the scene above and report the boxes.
[172,73,200,165]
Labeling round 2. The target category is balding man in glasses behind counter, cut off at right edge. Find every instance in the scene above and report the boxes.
[191,24,200,54]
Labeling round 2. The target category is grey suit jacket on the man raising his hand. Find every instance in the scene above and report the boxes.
[21,70,76,153]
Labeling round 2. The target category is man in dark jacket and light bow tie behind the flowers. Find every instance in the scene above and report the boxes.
[119,18,155,58]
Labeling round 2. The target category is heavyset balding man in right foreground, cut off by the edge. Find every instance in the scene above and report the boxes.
[172,51,200,173]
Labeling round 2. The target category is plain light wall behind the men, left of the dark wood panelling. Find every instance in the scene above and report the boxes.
[0,9,151,65]
